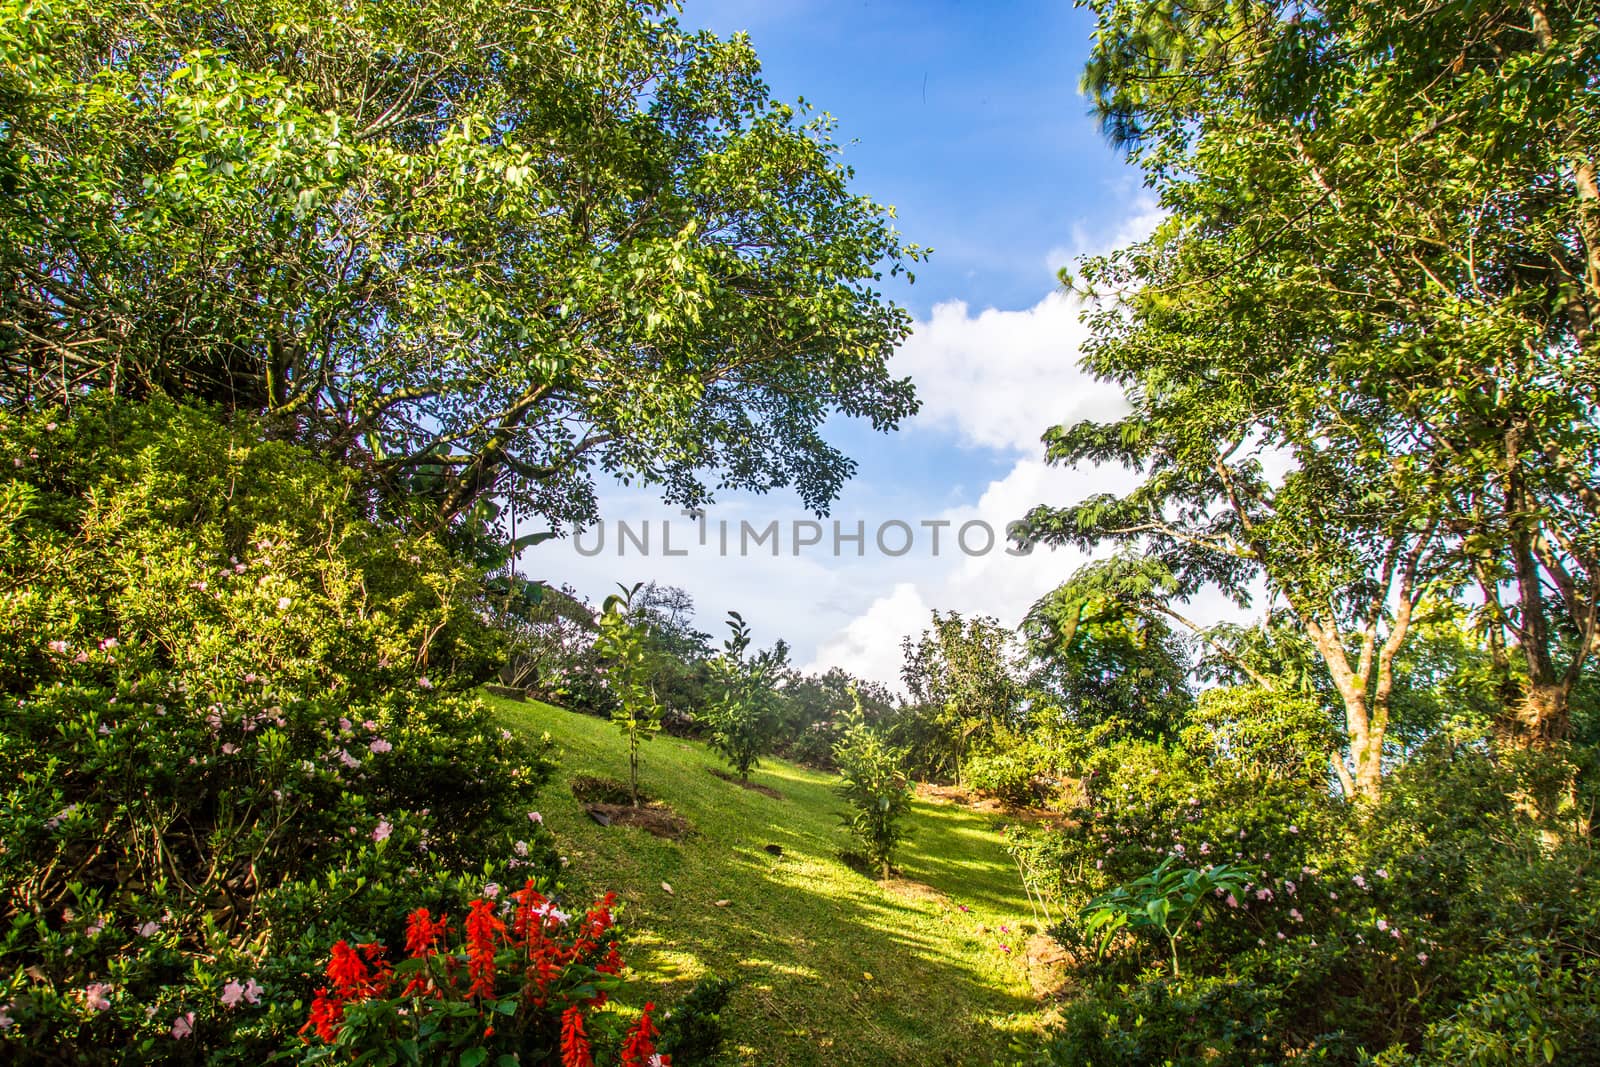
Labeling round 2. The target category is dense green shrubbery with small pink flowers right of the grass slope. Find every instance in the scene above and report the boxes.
[1013,694,1600,1067]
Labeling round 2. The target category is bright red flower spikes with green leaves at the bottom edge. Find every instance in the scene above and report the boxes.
[304,878,672,1067]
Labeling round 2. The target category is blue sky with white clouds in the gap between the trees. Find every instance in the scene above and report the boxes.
[537,0,1155,683]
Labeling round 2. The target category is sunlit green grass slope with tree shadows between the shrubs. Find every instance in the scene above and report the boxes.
[494,701,1038,1065]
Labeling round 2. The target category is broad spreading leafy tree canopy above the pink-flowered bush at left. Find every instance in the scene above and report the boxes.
[0,0,922,522]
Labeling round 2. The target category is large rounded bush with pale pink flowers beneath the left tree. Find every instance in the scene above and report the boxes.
[0,402,555,1064]
